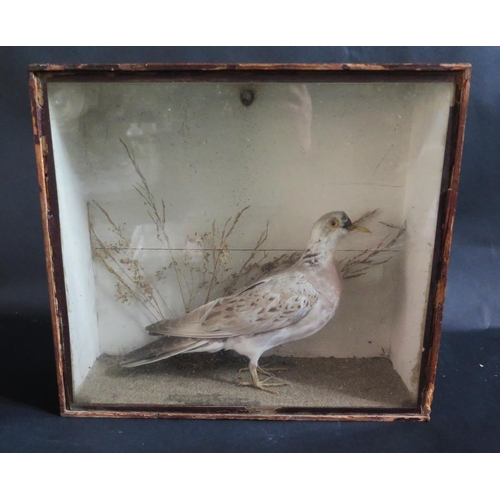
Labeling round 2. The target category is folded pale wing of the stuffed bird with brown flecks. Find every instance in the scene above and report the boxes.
[146,271,319,339]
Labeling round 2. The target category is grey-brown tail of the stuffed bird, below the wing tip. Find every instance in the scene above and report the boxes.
[120,337,209,368]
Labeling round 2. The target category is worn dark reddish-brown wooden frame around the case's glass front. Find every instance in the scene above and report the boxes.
[29,63,471,421]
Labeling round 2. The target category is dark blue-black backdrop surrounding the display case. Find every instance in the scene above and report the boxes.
[0,47,500,452]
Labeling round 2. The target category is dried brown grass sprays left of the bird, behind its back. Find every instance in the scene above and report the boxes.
[89,141,268,320]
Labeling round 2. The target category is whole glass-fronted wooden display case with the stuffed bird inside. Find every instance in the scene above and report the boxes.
[30,64,470,420]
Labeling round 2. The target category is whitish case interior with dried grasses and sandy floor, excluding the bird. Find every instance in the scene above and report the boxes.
[48,83,453,408]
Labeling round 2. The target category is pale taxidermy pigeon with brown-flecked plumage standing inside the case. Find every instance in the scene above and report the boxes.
[121,212,370,393]
